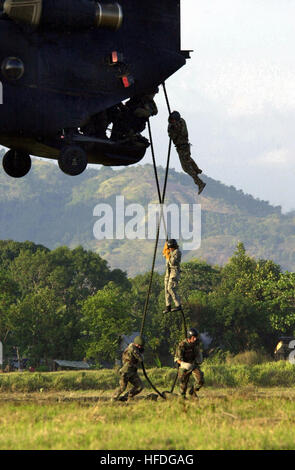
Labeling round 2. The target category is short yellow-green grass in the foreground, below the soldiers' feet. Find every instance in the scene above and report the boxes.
[0,387,295,450]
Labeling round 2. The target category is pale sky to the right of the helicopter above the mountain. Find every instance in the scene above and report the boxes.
[148,0,295,212]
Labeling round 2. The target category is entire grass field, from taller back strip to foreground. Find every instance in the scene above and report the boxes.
[0,362,295,450]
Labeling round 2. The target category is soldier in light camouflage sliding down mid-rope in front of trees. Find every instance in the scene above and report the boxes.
[163,239,181,313]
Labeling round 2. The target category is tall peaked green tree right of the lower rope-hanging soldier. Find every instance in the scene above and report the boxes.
[195,243,280,353]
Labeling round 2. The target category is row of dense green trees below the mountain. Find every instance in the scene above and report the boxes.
[0,241,295,365]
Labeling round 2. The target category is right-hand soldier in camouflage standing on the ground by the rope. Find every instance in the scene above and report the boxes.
[174,328,204,398]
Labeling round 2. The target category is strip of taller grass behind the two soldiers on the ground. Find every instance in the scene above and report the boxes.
[0,361,295,392]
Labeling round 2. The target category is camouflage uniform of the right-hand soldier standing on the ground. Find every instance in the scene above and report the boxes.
[174,339,204,396]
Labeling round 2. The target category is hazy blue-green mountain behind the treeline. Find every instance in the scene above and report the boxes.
[0,152,295,276]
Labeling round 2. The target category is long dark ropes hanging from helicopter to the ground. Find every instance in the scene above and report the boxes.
[140,83,187,400]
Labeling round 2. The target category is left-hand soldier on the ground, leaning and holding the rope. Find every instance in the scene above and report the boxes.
[113,336,144,400]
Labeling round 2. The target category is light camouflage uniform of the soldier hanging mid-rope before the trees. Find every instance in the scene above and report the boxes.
[165,248,181,307]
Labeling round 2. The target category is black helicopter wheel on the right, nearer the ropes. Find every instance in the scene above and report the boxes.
[58,145,88,176]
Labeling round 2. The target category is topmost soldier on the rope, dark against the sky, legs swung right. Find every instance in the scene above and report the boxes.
[168,111,206,194]
